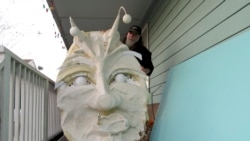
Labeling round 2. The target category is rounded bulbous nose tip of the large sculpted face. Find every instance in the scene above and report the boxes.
[88,94,120,111]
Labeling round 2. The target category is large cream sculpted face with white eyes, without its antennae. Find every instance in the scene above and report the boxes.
[56,17,148,141]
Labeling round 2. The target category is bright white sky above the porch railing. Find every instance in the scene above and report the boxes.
[0,0,67,81]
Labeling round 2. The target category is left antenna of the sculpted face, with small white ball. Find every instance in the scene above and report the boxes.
[69,17,87,42]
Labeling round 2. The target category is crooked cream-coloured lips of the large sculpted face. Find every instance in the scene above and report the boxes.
[92,113,129,135]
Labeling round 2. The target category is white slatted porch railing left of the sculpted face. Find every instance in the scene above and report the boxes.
[0,47,62,141]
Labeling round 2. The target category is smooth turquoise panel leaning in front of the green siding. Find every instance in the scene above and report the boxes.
[150,30,250,141]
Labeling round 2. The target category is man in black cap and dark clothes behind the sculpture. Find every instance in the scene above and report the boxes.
[123,25,154,76]
